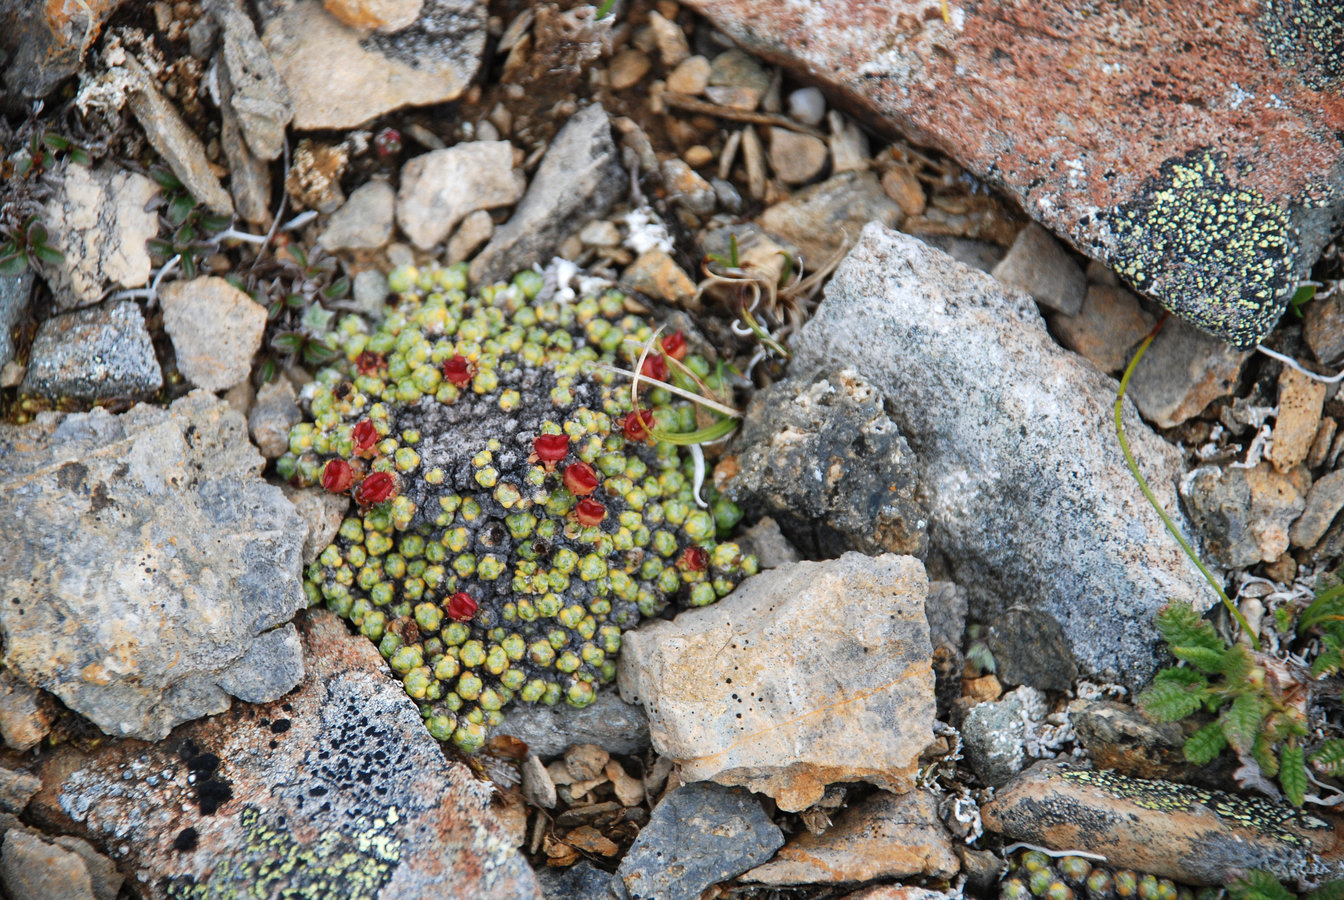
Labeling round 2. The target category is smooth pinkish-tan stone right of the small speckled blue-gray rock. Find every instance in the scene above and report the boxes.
[159,275,266,391]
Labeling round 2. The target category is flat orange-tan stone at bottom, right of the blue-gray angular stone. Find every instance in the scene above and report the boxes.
[742,790,961,887]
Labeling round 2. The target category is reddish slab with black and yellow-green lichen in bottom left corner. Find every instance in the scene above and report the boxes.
[30,610,540,900]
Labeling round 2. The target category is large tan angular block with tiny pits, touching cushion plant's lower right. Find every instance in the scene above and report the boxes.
[617,552,934,810]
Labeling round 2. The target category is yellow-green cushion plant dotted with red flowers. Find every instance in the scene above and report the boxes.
[277,266,757,752]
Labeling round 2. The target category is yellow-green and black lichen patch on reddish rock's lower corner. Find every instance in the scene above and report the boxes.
[1106,149,1297,348]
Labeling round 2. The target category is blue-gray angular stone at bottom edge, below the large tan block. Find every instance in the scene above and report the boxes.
[616,783,784,900]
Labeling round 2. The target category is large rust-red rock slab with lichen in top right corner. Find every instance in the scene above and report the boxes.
[688,0,1344,347]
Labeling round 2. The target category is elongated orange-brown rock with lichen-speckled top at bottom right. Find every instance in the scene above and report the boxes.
[981,763,1344,885]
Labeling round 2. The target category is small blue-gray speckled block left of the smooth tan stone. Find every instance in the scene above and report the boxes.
[19,300,164,400]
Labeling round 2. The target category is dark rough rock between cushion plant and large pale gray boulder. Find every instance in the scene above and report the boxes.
[719,368,929,559]
